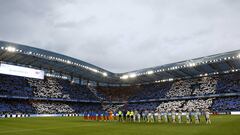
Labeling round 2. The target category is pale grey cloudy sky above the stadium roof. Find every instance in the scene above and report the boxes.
[0,0,240,72]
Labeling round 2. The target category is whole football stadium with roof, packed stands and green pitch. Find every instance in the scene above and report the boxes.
[0,41,240,134]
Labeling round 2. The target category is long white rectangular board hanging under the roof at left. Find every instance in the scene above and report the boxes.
[0,64,44,79]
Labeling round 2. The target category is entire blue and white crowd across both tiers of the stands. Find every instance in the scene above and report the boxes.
[0,74,240,114]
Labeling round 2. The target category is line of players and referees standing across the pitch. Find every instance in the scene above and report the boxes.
[84,109,211,124]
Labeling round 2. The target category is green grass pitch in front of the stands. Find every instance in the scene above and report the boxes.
[0,115,240,135]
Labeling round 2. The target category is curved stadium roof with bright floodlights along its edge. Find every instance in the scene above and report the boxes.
[0,41,240,84]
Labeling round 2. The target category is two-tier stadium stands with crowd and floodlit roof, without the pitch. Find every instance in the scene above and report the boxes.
[0,41,240,114]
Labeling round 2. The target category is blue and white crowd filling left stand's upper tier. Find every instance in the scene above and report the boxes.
[0,74,97,101]
